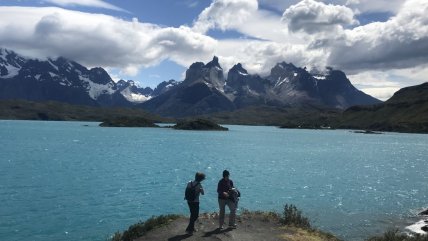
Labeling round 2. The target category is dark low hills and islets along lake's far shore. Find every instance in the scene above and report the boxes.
[0,100,428,134]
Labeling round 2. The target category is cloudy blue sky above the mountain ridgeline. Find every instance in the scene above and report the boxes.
[0,0,428,99]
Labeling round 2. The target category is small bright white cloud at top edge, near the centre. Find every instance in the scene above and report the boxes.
[193,0,258,33]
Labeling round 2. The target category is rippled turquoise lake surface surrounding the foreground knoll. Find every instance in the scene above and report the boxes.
[0,121,428,241]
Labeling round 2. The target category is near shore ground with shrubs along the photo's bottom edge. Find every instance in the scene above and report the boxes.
[109,204,428,241]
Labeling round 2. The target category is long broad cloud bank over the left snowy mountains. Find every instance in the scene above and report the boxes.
[0,7,217,75]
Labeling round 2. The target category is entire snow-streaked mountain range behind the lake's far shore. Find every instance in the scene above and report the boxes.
[0,48,381,117]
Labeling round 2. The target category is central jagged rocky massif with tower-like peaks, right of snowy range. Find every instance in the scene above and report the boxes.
[141,57,381,117]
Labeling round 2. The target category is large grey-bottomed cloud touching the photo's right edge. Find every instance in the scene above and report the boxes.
[328,0,428,72]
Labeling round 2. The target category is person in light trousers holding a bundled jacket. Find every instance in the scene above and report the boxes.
[217,170,237,229]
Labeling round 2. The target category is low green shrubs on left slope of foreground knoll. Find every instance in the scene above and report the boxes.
[111,214,180,241]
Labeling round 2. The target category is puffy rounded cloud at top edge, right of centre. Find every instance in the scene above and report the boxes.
[282,0,357,34]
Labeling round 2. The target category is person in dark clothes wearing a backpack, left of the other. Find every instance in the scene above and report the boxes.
[185,172,205,234]
